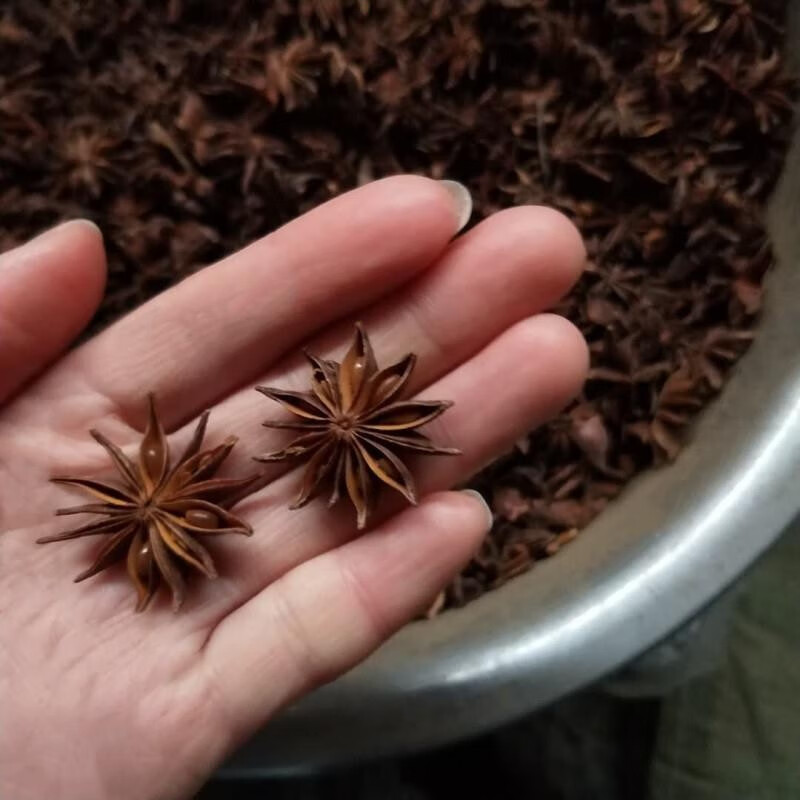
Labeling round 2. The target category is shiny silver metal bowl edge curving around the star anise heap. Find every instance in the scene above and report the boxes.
[225,14,800,775]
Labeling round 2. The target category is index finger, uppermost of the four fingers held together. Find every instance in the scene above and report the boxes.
[72,176,465,426]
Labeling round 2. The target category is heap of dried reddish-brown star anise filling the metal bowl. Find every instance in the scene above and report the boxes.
[0,0,794,608]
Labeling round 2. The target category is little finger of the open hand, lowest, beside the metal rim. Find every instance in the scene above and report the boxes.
[203,484,491,738]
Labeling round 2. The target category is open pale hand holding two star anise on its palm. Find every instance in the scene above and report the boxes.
[0,176,587,800]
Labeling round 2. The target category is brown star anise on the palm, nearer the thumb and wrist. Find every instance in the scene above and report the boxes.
[38,395,258,611]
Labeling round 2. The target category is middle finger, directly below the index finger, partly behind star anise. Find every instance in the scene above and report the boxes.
[202,206,585,454]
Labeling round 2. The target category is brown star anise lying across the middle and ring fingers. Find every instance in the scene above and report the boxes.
[256,324,460,529]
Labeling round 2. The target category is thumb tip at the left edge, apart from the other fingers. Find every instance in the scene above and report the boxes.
[0,220,106,402]
